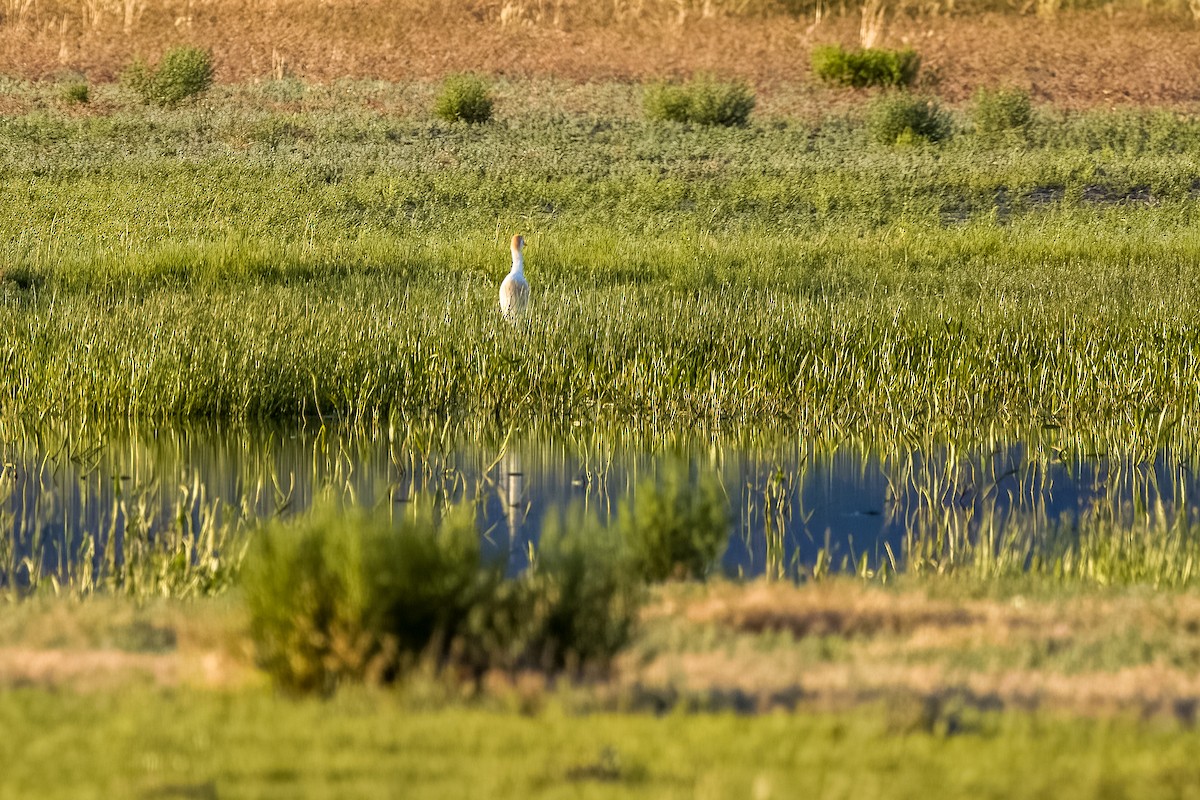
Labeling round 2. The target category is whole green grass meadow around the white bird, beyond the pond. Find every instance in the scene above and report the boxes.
[0,82,1200,438]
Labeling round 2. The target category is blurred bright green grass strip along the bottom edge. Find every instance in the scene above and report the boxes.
[0,690,1200,799]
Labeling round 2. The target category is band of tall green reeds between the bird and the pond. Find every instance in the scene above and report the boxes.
[7,266,1200,434]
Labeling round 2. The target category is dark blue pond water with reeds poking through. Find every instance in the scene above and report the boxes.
[0,425,1200,585]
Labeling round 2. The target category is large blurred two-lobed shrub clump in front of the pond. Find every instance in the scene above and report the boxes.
[244,505,640,692]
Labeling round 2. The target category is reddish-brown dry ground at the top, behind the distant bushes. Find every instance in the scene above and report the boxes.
[0,0,1200,108]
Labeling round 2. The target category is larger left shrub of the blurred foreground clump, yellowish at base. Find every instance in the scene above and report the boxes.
[242,506,498,692]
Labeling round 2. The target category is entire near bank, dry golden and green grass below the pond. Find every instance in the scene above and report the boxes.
[7,583,1200,798]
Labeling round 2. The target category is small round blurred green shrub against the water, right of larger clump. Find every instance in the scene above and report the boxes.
[619,470,730,581]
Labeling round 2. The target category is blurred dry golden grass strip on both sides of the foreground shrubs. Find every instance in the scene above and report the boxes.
[7,581,1200,723]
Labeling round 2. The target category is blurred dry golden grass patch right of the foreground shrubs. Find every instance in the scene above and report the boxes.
[618,582,1200,723]
